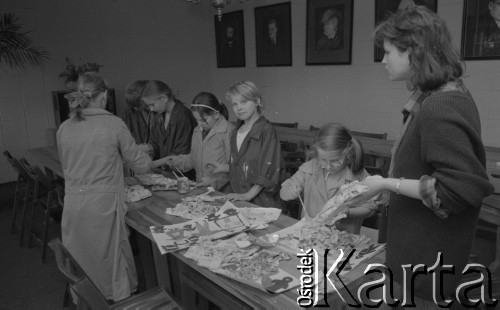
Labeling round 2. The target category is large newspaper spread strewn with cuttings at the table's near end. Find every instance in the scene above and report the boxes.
[184,184,384,293]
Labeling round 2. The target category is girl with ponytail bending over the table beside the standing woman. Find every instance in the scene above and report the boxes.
[280,123,377,234]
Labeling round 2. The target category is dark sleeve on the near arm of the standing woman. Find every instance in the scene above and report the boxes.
[419,92,493,213]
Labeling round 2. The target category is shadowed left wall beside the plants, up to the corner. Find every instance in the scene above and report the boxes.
[0,0,213,183]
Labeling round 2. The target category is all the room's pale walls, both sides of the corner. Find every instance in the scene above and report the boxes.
[0,0,500,183]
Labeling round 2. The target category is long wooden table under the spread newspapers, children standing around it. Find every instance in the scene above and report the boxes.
[127,189,385,309]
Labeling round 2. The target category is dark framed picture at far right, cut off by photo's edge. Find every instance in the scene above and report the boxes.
[461,0,500,60]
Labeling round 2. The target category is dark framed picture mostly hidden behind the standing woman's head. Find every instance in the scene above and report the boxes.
[373,0,437,62]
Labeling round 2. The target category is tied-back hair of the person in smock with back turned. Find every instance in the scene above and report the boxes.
[70,72,108,121]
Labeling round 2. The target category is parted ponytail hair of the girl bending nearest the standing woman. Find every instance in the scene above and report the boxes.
[311,123,364,174]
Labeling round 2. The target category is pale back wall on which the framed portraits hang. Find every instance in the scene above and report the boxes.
[207,0,500,146]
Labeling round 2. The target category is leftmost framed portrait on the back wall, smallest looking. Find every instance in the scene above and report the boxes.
[214,10,246,68]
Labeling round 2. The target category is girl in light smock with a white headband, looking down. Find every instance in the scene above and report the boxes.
[161,92,234,190]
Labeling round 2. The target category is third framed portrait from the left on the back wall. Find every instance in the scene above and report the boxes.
[306,0,353,65]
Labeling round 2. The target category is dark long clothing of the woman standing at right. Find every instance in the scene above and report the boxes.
[387,84,493,300]
